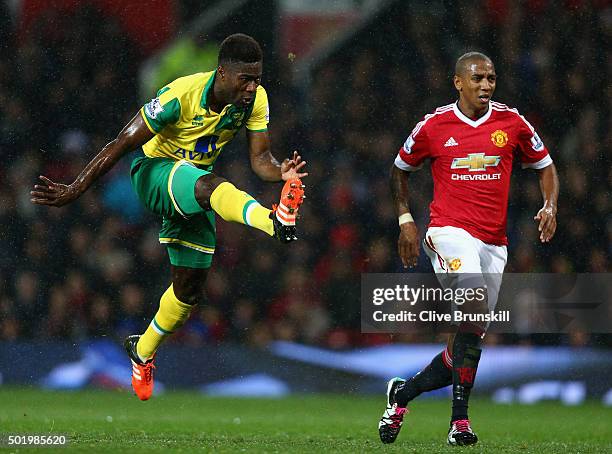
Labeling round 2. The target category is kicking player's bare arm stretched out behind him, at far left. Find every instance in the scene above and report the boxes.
[30,113,153,207]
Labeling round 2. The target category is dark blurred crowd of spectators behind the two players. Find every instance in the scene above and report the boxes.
[0,0,612,348]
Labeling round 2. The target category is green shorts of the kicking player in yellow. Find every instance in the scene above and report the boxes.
[130,155,216,268]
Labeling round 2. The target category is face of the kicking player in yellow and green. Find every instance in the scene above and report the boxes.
[220,62,262,107]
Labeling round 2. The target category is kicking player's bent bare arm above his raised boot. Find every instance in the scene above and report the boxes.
[247,131,308,181]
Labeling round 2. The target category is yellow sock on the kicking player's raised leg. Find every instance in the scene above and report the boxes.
[210,181,274,236]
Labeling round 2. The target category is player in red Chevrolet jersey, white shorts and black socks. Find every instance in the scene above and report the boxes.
[379,52,559,445]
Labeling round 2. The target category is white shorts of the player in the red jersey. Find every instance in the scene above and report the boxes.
[423,226,508,310]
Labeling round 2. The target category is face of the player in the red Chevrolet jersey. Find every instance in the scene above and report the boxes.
[455,60,497,111]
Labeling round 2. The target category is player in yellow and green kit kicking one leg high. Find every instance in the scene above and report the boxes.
[31,34,307,400]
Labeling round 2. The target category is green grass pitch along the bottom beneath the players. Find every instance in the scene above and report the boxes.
[0,387,612,454]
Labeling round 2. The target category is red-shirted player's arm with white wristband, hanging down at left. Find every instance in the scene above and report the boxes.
[390,165,419,268]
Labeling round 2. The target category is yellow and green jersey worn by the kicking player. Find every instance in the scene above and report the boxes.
[140,71,269,167]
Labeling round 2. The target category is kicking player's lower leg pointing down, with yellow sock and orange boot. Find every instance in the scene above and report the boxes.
[125,266,208,400]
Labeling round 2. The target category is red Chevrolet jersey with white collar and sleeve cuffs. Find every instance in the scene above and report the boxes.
[395,101,552,245]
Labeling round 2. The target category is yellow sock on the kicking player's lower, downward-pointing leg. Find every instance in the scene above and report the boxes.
[136,285,193,361]
